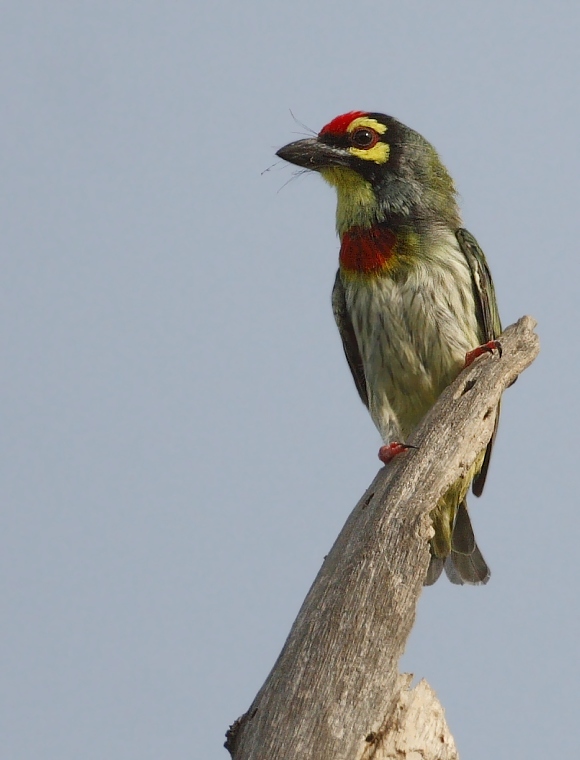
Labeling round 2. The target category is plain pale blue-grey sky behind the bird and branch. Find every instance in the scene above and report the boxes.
[0,0,580,760]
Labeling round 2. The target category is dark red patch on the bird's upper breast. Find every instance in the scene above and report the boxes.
[340,227,397,274]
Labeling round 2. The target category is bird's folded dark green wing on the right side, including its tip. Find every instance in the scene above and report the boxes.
[455,229,501,496]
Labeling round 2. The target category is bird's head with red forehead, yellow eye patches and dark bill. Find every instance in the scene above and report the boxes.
[276,111,460,234]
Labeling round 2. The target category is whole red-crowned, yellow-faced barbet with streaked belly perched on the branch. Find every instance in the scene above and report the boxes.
[276,111,501,585]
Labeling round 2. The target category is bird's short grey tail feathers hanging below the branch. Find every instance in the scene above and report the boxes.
[425,499,491,586]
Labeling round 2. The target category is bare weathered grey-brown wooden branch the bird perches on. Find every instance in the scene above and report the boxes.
[226,317,539,760]
